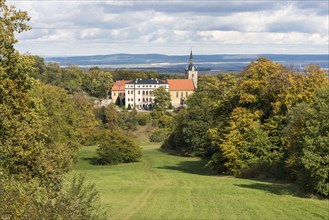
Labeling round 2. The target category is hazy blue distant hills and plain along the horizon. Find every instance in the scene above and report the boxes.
[45,54,329,73]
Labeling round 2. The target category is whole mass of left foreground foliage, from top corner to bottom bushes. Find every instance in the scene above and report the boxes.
[0,0,105,219]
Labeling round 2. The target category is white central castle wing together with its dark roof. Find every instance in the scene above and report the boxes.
[125,79,169,109]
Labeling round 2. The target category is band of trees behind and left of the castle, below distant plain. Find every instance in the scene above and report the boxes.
[30,56,183,98]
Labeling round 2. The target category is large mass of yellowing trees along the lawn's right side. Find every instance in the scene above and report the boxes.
[162,58,329,196]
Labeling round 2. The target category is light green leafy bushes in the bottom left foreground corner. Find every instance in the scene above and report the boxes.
[0,175,106,220]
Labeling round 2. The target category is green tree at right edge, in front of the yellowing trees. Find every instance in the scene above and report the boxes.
[285,86,329,196]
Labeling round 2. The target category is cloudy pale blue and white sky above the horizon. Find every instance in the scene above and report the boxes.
[7,0,329,56]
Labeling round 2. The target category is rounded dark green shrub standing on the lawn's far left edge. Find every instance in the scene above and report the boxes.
[95,131,142,165]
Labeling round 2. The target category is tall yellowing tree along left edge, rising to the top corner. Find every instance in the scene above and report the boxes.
[0,0,47,183]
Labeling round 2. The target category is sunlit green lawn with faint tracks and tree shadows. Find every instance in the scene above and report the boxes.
[76,145,329,219]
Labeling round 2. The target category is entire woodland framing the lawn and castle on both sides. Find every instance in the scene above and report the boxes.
[0,0,329,219]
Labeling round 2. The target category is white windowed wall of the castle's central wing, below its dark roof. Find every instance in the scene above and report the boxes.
[125,84,169,109]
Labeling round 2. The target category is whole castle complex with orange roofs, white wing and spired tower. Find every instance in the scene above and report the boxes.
[111,51,198,110]
